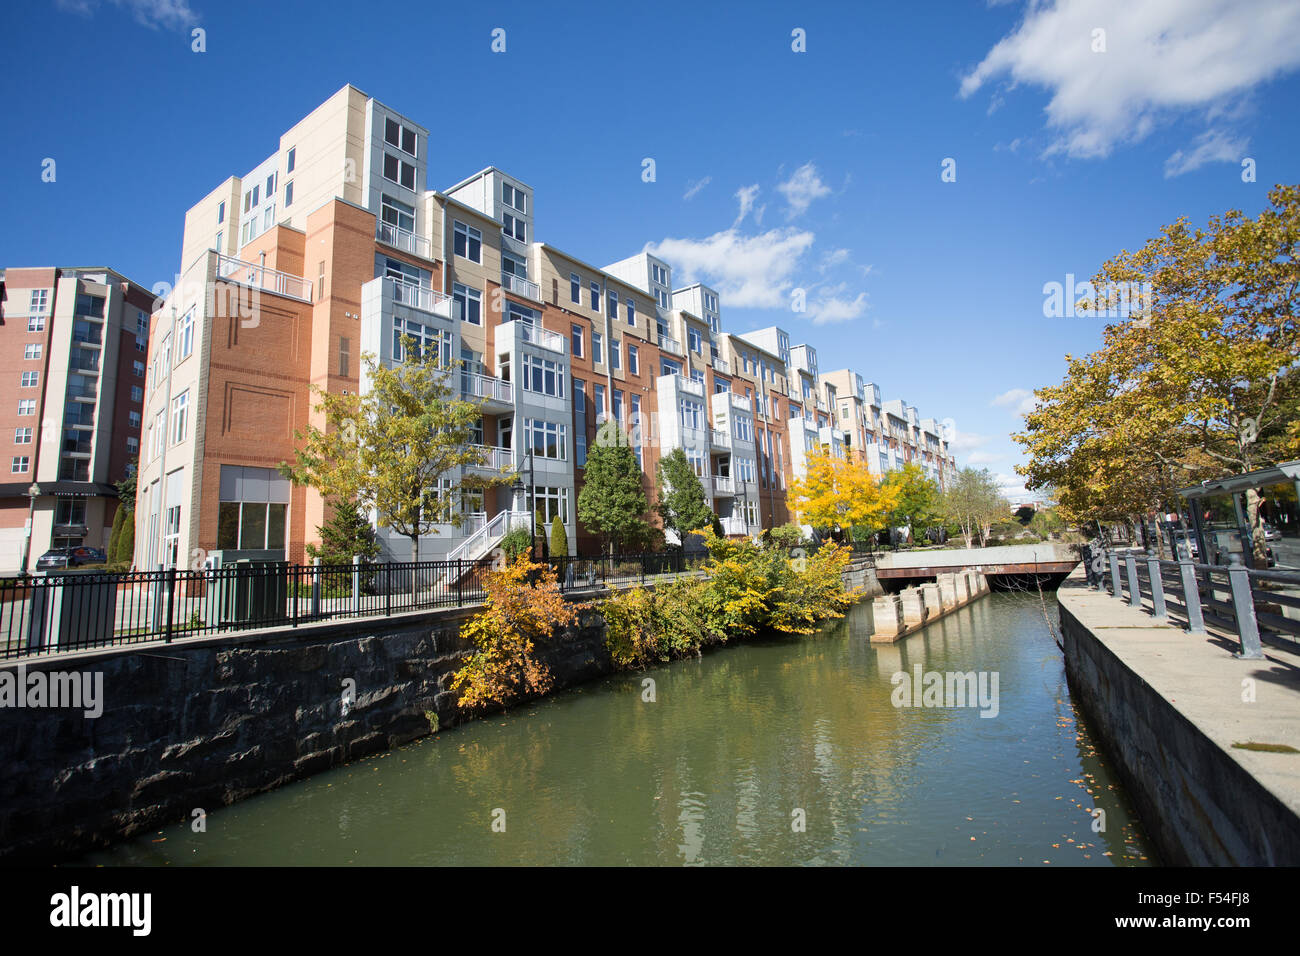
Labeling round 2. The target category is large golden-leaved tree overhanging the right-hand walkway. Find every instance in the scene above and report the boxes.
[1015,186,1300,564]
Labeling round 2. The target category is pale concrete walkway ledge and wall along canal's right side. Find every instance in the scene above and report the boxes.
[1057,568,1300,866]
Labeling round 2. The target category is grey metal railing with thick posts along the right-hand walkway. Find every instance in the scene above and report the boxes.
[1083,545,1300,659]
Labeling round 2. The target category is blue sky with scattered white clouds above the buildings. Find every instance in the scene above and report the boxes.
[0,0,1300,502]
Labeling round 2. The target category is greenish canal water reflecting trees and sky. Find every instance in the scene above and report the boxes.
[86,593,1154,866]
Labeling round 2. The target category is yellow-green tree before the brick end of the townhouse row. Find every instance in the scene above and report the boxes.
[281,337,514,572]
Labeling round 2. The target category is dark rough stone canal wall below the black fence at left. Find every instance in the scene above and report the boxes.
[0,600,614,862]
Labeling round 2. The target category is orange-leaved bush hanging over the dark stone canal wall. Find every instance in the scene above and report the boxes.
[451,553,577,710]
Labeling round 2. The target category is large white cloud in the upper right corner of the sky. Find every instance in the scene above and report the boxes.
[961,0,1300,157]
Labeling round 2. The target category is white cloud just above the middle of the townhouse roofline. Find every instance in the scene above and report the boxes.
[646,227,814,308]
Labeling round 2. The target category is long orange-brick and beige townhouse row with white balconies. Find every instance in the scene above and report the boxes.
[114,86,954,567]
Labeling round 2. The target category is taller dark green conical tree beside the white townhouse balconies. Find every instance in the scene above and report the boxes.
[577,419,650,554]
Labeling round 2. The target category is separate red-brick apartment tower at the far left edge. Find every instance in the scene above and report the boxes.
[0,267,153,574]
